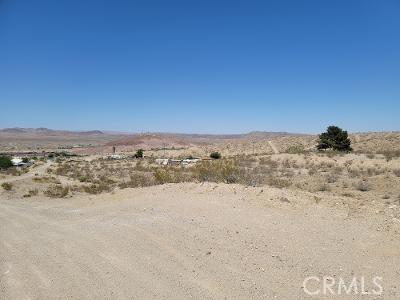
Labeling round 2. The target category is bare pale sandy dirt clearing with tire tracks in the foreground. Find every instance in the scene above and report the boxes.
[0,184,400,300]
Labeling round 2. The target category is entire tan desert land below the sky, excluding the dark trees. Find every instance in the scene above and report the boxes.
[0,128,400,299]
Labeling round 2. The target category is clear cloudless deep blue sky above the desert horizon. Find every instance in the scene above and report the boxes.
[0,0,400,133]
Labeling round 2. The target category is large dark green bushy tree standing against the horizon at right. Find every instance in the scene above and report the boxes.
[317,126,353,152]
